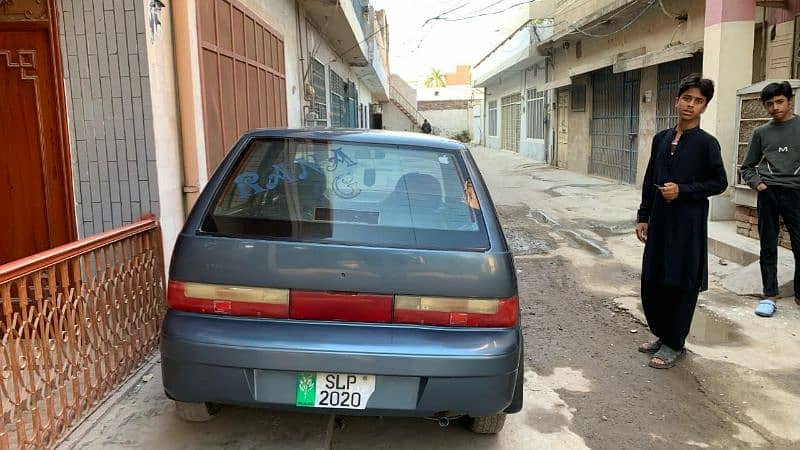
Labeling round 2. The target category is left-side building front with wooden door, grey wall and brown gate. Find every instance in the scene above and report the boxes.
[0,0,389,264]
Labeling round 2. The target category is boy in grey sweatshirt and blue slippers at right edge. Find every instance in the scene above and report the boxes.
[742,81,800,317]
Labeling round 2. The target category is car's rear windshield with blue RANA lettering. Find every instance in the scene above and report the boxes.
[202,139,489,250]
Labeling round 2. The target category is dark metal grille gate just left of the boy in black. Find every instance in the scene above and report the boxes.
[589,68,641,184]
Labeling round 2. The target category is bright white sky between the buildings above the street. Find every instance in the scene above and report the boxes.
[370,0,529,81]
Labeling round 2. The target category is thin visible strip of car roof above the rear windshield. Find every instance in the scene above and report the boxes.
[245,128,466,150]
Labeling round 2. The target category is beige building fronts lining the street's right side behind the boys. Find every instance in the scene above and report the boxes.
[475,0,800,246]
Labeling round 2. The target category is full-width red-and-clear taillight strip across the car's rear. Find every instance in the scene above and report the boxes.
[167,281,519,327]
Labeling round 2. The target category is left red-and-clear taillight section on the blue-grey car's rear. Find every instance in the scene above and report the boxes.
[167,281,289,318]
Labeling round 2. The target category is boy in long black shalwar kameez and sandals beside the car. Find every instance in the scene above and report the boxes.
[636,75,728,369]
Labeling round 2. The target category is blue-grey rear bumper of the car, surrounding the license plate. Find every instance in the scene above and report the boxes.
[161,311,520,416]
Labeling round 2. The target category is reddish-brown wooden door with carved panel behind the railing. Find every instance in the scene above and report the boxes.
[0,1,76,264]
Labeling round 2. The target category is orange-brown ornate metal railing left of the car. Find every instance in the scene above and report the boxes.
[0,218,165,449]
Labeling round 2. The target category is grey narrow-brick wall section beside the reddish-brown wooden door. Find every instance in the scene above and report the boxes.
[57,0,163,237]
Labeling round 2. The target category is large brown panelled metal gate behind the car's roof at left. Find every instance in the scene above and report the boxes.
[197,0,288,174]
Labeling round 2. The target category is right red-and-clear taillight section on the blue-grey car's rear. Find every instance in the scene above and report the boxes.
[394,295,518,327]
